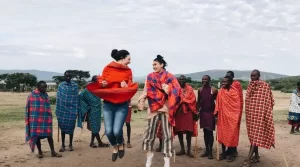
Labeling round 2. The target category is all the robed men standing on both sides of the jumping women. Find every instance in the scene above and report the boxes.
[25,70,275,166]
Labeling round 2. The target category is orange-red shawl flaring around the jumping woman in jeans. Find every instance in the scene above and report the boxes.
[86,62,138,104]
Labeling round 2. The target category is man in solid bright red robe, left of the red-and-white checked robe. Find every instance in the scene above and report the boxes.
[214,77,242,162]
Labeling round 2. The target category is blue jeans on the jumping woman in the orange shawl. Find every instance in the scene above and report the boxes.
[103,102,129,146]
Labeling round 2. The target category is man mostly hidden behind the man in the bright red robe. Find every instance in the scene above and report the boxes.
[226,71,244,156]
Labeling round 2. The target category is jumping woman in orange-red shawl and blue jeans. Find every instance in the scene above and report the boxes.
[87,49,138,161]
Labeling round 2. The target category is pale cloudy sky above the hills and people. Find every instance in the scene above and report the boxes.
[0,0,300,76]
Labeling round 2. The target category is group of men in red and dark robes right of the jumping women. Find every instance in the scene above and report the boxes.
[165,70,275,167]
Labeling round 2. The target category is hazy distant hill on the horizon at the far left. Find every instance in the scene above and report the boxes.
[0,70,63,81]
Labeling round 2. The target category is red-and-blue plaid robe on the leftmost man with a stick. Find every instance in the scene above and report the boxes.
[25,90,52,152]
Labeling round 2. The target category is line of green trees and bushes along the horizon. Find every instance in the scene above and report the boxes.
[0,70,300,93]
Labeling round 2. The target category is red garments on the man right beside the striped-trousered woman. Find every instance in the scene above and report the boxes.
[175,84,198,137]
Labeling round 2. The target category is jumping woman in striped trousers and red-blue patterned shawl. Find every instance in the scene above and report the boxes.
[138,55,182,167]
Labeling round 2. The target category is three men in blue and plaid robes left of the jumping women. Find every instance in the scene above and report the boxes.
[25,71,109,158]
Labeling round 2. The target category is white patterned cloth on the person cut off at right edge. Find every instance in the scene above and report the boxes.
[288,89,300,121]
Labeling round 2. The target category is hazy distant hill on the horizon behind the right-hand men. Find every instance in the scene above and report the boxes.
[176,70,288,81]
